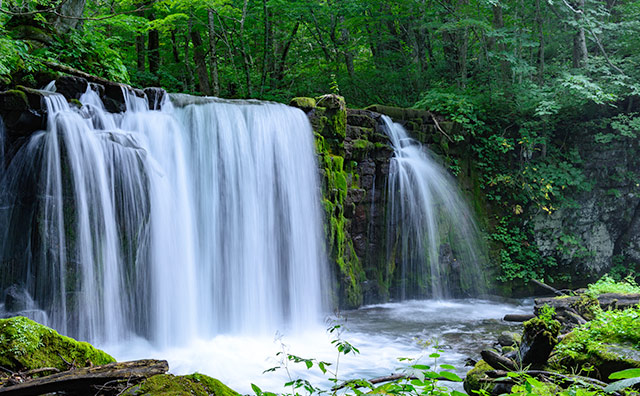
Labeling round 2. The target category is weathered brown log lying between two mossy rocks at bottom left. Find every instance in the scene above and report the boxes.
[0,360,169,396]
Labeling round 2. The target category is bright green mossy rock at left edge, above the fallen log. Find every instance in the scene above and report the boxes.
[0,316,115,371]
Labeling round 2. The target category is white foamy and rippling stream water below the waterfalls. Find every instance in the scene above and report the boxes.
[103,299,533,393]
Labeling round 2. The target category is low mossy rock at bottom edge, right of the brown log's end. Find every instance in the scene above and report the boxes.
[123,373,239,396]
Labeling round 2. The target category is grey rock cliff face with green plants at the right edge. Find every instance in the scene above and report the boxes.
[533,106,640,286]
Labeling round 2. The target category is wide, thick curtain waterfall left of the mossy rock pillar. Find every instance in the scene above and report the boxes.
[0,89,328,345]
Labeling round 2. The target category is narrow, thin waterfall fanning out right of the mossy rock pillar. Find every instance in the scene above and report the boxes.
[383,116,486,299]
